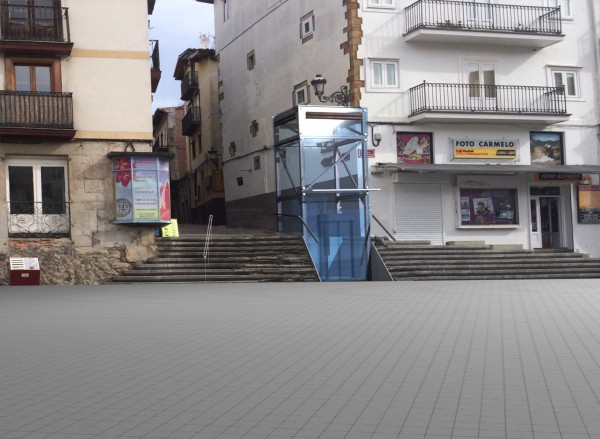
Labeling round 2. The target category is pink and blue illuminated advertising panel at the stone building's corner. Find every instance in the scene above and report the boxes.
[112,155,171,224]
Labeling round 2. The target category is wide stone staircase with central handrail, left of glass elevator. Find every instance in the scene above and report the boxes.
[112,232,319,283]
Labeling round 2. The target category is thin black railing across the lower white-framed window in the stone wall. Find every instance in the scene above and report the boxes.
[8,201,71,236]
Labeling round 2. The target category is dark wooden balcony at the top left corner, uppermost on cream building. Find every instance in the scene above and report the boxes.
[0,0,73,56]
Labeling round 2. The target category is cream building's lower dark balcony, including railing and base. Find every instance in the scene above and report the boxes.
[0,90,75,140]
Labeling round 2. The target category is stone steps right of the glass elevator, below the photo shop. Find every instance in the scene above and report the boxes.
[375,241,600,281]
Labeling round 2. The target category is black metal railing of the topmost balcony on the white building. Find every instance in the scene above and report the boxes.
[404,0,562,35]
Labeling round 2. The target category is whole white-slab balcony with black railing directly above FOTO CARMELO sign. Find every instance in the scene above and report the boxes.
[409,82,570,125]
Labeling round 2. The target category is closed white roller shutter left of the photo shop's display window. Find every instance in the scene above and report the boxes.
[395,183,444,245]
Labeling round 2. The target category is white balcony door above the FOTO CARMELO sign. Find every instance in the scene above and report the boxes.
[465,62,497,111]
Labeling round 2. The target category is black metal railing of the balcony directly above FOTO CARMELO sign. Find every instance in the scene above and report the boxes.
[409,82,567,116]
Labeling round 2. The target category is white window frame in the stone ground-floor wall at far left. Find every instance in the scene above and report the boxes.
[6,157,71,234]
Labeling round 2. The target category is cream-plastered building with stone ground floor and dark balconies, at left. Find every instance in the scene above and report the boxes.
[0,0,164,284]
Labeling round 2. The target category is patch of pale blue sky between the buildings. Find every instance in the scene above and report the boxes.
[148,0,215,111]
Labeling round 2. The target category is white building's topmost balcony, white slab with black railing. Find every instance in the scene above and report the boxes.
[404,0,564,48]
